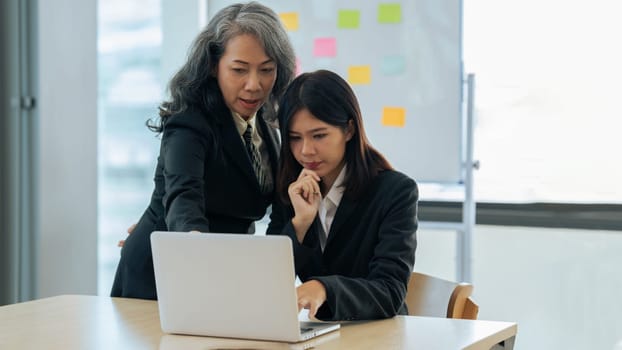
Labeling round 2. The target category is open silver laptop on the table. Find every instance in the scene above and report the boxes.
[151,231,340,342]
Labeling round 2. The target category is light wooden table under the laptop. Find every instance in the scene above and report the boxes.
[0,295,517,350]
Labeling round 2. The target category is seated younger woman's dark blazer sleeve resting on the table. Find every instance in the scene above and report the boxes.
[310,176,418,320]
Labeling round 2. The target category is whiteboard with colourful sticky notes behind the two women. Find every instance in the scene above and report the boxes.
[207,0,464,183]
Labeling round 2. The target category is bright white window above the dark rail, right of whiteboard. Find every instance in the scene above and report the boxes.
[464,0,622,203]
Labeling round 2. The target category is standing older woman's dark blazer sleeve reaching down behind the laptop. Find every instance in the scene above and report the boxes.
[160,113,213,232]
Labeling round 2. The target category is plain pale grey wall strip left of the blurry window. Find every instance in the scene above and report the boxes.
[35,0,97,297]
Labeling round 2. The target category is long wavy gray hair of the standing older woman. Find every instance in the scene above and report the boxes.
[150,1,295,132]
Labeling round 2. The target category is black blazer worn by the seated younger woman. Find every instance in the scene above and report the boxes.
[267,171,419,320]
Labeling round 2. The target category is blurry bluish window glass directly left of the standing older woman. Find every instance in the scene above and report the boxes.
[98,0,163,295]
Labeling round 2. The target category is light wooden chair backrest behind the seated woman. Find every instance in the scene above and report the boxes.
[406,272,479,320]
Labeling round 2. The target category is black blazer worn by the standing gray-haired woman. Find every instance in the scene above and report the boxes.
[111,105,279,299]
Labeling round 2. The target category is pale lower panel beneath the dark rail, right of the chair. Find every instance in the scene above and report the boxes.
[472,225,622,350]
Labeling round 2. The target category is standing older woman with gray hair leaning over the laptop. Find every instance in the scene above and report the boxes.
[111,2,295,299]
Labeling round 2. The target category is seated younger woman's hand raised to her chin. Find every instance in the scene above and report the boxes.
[287,169,322,242]
